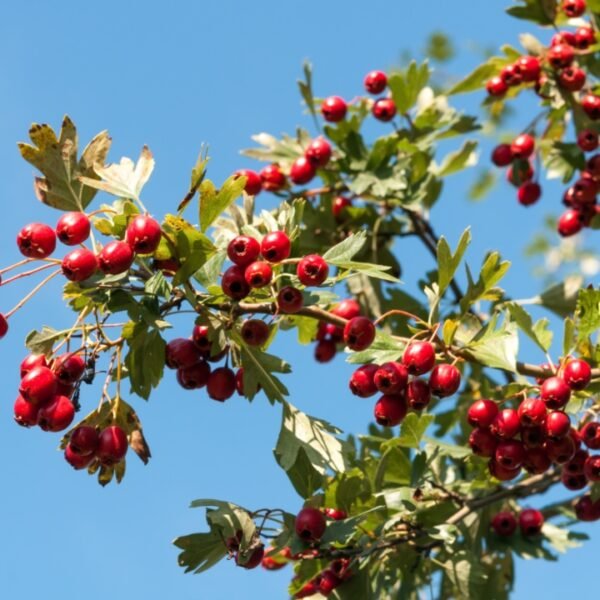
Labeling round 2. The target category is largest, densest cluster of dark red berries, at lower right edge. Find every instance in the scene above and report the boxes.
[467,359,600,490]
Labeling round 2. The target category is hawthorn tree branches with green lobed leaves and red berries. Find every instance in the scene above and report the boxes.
[5,0,600,600]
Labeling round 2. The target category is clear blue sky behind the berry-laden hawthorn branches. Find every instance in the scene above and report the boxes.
[0,0,600,600]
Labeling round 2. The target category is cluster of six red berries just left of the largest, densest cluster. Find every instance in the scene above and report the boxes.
[350,341,460,427]
